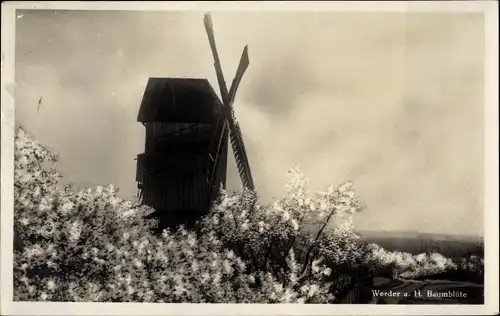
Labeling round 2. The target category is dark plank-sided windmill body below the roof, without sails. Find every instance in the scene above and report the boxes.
[136,118,228,227]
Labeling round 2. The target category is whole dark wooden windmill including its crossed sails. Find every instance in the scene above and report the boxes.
[136,14,255,227]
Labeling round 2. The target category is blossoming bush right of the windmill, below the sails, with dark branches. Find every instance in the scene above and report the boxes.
[200,167,365,303]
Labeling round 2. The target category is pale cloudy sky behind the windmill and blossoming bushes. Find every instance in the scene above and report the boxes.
[16,10,484,235]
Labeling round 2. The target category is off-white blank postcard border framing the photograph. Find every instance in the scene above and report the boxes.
[0,1,499,315]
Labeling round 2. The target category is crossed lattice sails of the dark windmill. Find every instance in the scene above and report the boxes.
[204,14,255,190]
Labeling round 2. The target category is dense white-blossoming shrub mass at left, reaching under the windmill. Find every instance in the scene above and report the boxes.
[14,128,350,303]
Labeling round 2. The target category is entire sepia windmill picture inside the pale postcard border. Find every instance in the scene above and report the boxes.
[2,3,496,314]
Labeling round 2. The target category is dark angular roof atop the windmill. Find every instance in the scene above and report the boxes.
[137,78,222,123]
